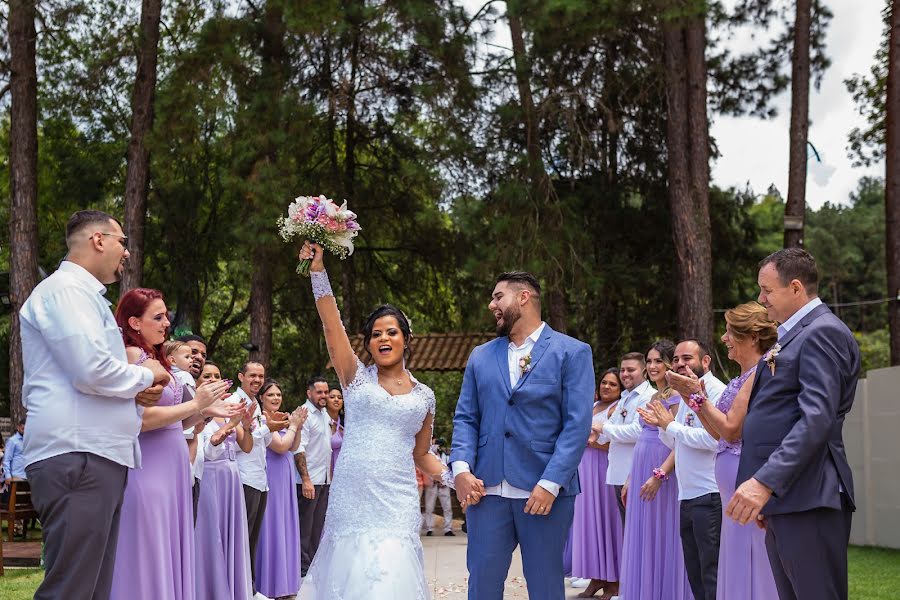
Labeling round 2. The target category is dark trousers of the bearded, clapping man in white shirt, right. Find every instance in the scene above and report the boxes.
[680,493,722,600]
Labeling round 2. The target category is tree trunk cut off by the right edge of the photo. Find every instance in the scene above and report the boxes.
[884,0,900,365]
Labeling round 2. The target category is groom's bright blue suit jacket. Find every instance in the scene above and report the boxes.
[450,325,594,496]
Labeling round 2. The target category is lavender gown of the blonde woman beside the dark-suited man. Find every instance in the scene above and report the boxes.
[716,366,778,600]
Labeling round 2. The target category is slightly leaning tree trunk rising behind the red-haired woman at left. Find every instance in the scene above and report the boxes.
[121,0,162,293]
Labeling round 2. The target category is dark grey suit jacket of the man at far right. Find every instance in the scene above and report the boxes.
[737,304,860,515]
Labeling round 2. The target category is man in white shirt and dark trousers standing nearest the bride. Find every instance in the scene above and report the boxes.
[294,377,331,577]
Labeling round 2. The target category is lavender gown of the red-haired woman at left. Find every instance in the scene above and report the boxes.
[110,364,195,600]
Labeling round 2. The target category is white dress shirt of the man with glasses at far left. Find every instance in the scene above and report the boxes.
[19,261,153,468]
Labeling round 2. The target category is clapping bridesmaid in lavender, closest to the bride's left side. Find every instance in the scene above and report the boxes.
[256,379,307,598]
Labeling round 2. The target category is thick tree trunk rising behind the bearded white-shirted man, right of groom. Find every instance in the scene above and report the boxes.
[663,12,713,343]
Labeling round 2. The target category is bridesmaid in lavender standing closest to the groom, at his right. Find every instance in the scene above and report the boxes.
[572,368,624,600]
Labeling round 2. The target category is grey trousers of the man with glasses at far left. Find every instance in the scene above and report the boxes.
[25,452,128,600]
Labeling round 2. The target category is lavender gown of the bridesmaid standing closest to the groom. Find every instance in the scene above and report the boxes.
[572,407,623,582]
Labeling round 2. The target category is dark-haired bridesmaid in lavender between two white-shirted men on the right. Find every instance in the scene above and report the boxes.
[598,340,694,600]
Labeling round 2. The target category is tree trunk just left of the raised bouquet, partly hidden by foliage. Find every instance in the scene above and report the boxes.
[250,0,285,368]
